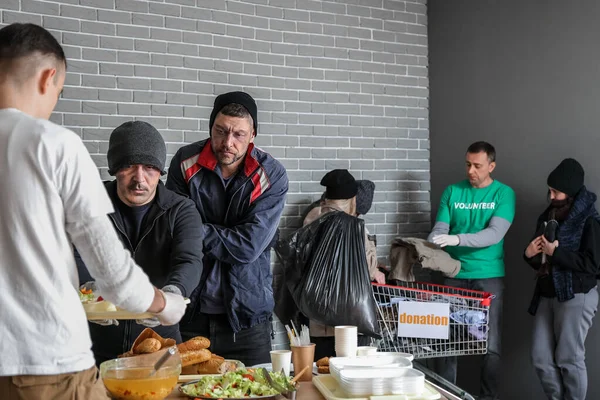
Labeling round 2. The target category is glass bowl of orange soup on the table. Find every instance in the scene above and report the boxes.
[100,349,181,400]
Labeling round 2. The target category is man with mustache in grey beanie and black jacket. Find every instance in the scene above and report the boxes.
[77,121,203,364]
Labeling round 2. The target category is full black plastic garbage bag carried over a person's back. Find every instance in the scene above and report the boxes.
[275,212,380,338]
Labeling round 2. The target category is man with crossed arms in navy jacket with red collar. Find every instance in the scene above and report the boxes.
[167,92,288,365]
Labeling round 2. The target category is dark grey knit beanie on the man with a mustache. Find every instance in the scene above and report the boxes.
[106,121,167,175]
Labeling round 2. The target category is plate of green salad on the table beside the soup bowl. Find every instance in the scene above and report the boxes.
[179,368,296,400]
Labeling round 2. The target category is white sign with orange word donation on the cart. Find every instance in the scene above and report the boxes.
[397,301,450,339]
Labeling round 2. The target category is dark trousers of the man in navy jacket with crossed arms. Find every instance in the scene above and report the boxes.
[181,313,272,367]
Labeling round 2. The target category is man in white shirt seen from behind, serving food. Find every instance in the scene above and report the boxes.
[0,23,185,400]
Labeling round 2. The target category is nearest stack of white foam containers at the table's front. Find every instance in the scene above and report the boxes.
[339,368,425,397]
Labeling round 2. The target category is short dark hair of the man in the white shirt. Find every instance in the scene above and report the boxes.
[0,23,67,83]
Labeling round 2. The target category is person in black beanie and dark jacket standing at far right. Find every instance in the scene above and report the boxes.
[524,158,600,400]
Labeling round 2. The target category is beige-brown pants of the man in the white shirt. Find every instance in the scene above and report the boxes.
[0,366,110,400]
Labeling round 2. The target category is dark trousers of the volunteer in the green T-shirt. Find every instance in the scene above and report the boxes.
[435,278,504,400]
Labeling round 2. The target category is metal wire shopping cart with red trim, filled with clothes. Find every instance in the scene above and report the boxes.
[373,282,494,359]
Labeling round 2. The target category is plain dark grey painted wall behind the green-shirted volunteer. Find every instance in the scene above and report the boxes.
[428,0,600,400]
